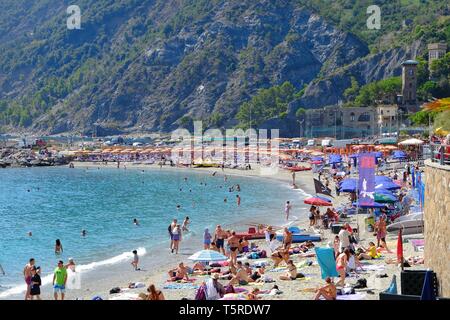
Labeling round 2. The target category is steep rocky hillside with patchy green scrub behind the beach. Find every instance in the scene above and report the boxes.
[0,0,450,134]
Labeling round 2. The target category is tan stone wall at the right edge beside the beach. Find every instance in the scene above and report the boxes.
[424,160,450,297]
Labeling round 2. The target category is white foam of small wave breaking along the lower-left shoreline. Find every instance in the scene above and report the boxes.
[0,247,147,298]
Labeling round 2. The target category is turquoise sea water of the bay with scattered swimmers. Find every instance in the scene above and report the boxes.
[0,168,308,298]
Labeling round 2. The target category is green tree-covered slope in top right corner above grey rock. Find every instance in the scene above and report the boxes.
[298,0,450,52]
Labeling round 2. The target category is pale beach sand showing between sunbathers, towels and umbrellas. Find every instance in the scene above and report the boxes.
[20,162,423,300]
